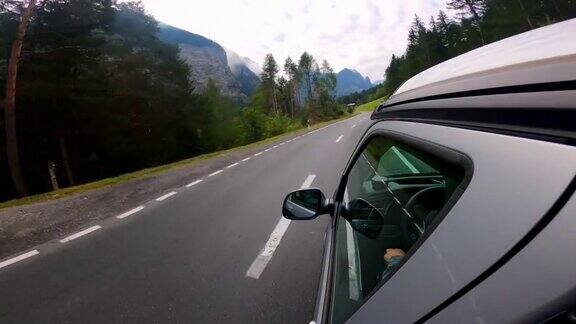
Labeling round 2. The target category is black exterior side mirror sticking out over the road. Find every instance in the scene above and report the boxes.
[282,189,332,220]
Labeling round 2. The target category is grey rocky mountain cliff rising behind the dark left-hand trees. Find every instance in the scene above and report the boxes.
[158,23,260,102]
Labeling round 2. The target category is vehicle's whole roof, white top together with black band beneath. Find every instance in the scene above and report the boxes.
[371,19,576,146]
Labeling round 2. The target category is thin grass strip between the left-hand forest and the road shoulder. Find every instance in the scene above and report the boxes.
[0,112,358,209]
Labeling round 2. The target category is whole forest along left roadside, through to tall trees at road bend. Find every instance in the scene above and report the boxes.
[0,0,341,200]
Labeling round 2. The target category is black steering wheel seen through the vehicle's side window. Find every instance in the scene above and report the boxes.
[401,186,446,245]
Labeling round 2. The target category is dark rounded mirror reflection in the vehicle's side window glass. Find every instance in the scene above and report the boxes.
[344,198,384,238]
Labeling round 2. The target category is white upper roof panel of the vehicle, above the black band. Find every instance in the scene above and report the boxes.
[386,19,576,106]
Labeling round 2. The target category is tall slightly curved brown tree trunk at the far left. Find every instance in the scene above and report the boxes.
[4,0,36,197]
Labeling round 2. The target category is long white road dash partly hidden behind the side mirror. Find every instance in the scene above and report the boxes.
[246,174,316,279]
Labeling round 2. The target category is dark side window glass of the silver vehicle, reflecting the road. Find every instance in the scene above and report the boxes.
[330,137,464,323]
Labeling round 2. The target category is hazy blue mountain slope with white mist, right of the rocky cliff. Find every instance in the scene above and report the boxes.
[225,49,262,95]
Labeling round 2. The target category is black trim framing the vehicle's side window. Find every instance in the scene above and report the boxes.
[322,129,474,323]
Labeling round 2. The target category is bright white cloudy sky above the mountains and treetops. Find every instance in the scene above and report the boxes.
[142,0,446,81]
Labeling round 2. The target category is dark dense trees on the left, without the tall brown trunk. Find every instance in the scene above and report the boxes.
[0,0,242,198]
